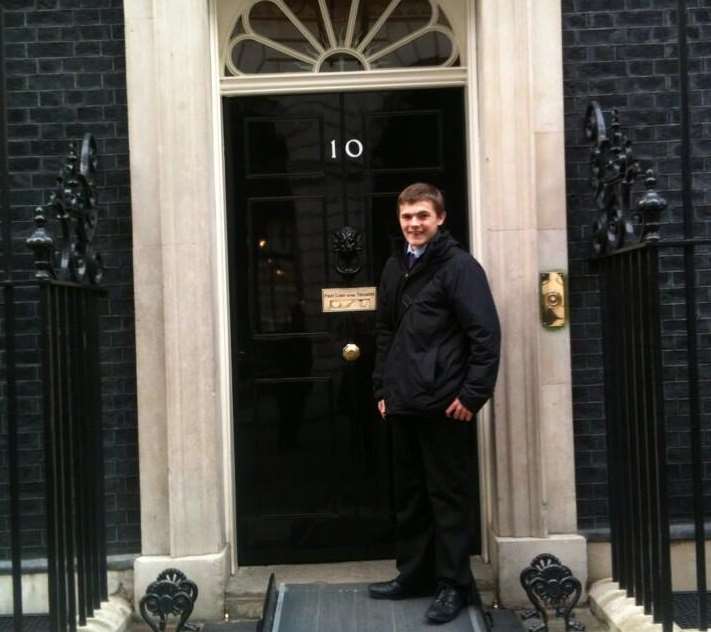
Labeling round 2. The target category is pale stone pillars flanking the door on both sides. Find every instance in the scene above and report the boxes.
[124,0,586,618]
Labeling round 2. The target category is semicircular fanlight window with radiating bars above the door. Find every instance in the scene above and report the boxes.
[224,0,459,76]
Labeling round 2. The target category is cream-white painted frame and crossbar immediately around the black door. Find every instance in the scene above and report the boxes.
[209,0,491,570]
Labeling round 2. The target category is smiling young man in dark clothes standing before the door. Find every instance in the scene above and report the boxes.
[369,183,500,623]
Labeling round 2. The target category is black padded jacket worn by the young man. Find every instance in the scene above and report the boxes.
[373,230,501,417]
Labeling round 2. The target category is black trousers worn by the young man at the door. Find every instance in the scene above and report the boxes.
[388,416,475,588]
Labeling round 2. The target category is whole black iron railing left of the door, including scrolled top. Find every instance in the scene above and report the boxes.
[0,134,108,632]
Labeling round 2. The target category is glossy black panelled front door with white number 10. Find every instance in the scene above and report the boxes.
[223,89,479,564]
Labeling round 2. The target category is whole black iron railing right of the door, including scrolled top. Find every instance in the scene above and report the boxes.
[586,102,674,632]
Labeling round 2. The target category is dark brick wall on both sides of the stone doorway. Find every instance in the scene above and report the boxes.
[0,0,711,559]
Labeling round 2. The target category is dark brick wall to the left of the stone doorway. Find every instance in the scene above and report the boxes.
[0,0,140,559]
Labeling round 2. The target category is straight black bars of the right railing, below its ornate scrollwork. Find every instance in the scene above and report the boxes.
[599,243,673,632]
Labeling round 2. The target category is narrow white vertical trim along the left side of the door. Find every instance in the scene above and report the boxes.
[208,0,237,572]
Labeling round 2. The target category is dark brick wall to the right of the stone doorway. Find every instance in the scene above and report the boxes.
[562,0,711,529]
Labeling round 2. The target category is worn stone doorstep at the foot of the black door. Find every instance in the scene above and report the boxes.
[225,556,495,621]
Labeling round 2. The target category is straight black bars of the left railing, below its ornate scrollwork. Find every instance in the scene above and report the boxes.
[0,280,108,632]
